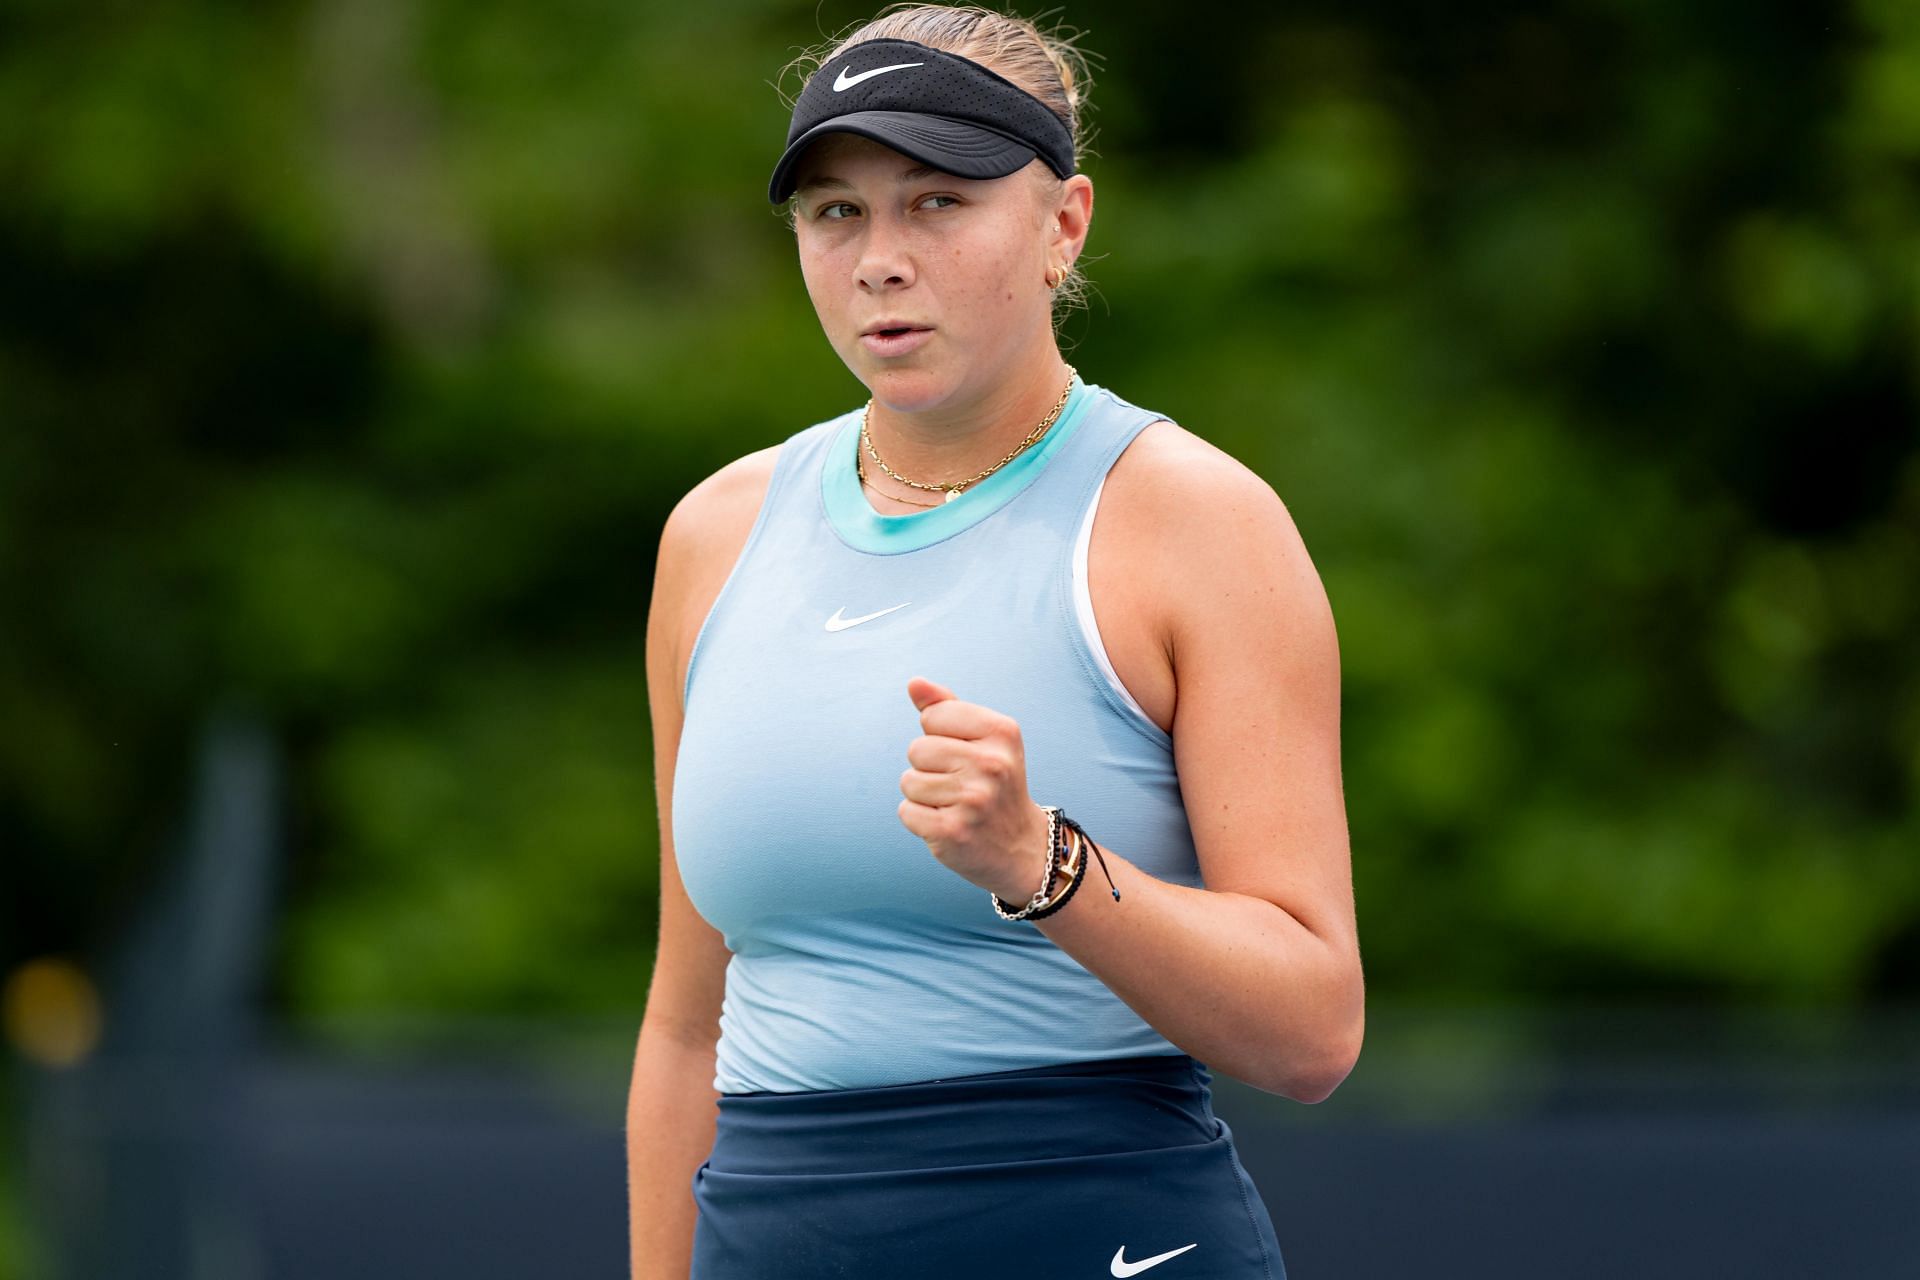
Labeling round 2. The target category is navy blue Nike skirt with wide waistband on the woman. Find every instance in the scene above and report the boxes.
[691,1054,1286,1280]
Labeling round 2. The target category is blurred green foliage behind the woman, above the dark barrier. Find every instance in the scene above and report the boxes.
[0,0,1920,1015]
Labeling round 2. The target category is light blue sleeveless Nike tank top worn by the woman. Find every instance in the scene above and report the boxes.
[672,378,1200,1094]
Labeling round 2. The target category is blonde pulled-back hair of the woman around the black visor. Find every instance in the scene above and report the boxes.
[776,2,1096,320]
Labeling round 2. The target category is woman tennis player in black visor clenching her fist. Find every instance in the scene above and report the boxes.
[628,6,1363,1280]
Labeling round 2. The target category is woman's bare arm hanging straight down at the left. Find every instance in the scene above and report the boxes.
[626,449,774,1280]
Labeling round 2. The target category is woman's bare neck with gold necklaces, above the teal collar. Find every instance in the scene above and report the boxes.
[866,349,1068,503]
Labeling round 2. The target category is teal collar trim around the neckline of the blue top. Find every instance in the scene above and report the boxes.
[820,374,1092,555]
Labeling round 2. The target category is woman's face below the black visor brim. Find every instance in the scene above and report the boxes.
[795,132,1087,411]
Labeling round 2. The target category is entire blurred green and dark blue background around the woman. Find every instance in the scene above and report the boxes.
[0,0,1920,1280]
